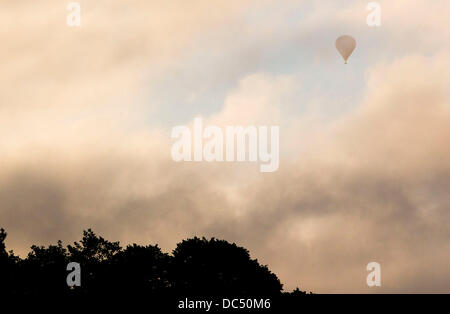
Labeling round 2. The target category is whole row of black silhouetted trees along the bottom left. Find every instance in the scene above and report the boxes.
[0,229,305,306]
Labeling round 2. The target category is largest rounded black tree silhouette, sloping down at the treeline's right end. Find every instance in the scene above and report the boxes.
[171,238,282,296]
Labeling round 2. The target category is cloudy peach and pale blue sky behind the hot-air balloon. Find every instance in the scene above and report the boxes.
[0,0,450,293]
